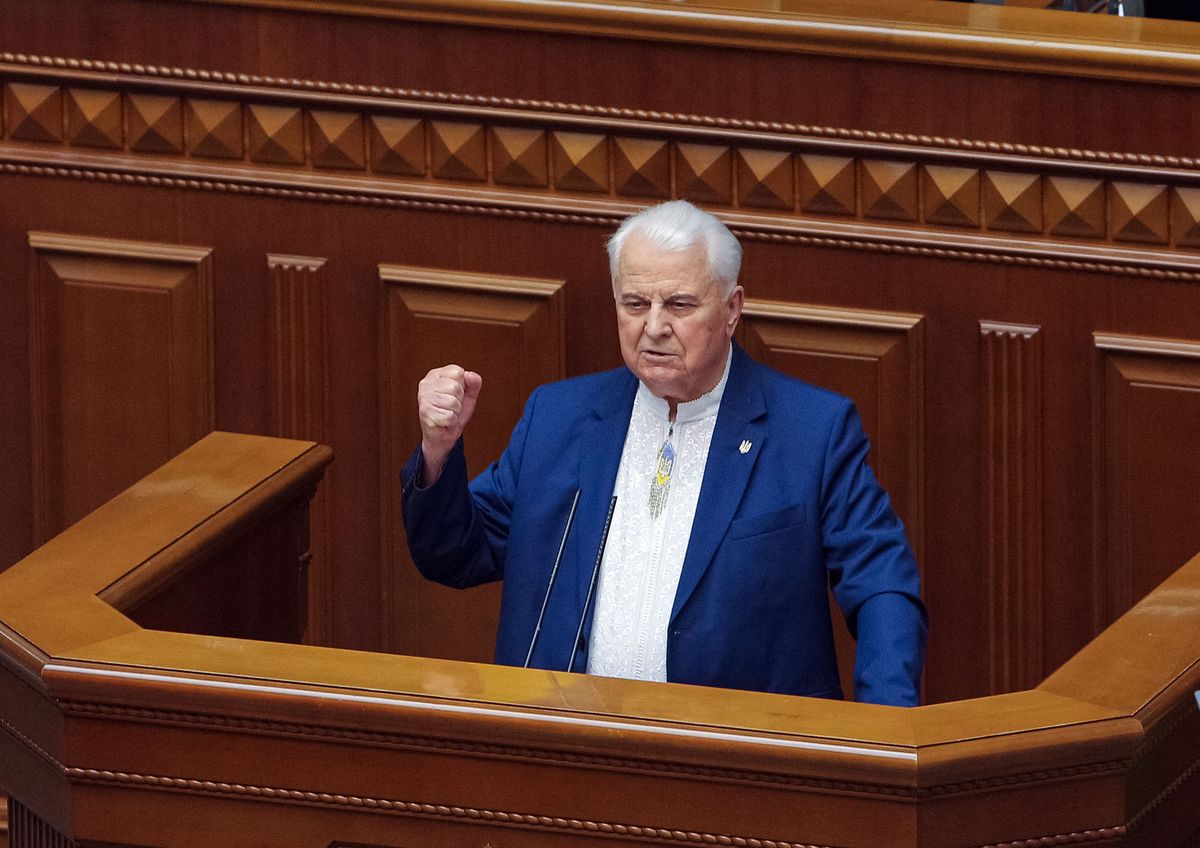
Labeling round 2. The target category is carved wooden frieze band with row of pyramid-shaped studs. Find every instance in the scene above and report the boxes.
[7,53,1200,278]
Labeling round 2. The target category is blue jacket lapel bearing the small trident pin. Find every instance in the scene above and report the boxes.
[672,345,767,621]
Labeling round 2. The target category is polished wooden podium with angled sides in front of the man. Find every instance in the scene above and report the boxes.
[0,433,1200,848]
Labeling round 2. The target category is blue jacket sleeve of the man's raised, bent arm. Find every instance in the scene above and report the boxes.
[401,391,538,589]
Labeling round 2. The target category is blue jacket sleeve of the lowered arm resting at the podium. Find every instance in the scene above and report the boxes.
[821,402,928,706]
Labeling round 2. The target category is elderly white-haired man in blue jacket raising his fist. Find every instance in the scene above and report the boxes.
[402,200,925,705]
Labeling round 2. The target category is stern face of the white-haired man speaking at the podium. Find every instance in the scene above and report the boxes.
[616,231,743,411]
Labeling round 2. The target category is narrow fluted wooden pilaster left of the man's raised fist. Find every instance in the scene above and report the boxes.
[266,255,336,644]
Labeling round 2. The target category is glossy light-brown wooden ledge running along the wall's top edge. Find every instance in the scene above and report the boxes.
[58,0,1200,85]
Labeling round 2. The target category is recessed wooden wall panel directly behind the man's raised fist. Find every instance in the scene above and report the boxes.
[379,265,566,662]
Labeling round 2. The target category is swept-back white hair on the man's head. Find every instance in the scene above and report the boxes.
[607,200,742,297]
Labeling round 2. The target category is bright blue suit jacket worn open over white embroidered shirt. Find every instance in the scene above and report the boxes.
[402,345,925,705]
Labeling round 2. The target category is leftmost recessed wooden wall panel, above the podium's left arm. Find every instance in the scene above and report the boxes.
[29,233,214,542]
